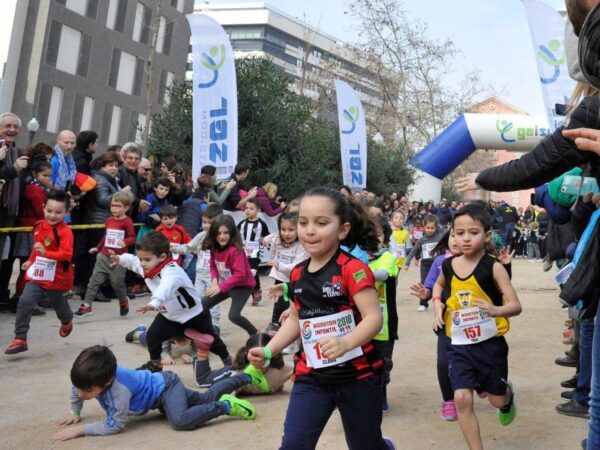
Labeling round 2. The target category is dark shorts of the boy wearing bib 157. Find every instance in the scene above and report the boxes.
[448,336,508,395]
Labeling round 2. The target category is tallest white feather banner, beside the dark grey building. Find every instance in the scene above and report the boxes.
[187,14,238,179]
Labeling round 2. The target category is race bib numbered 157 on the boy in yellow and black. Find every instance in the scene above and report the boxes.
[448,308,498,345]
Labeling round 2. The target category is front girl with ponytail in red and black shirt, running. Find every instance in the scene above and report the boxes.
[248,188,394,450]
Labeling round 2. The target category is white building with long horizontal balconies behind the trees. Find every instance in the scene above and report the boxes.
[193,2,395,138]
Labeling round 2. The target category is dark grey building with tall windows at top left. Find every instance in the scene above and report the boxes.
[0,0,193,147]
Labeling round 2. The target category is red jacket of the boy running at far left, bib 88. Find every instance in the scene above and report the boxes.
[25,220,73,291]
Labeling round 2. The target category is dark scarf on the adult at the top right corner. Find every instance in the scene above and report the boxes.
[579,3,600,88]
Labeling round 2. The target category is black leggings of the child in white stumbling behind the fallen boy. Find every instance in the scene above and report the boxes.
[146,310,229,361]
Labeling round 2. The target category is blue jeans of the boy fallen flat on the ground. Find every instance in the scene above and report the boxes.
[155,372,248,430]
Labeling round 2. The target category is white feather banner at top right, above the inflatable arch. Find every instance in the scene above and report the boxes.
[523,0,575,131]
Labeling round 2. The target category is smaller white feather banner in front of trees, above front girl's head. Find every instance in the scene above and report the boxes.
[335,80,367,191]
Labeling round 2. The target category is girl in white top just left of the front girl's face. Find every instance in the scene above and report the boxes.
[264,212,309,335]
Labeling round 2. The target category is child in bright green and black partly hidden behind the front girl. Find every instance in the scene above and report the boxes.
[369,218,398,412]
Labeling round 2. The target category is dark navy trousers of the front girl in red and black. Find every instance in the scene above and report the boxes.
[282,374,388,450]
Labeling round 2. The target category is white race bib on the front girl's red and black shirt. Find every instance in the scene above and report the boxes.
[300,311,363,369]
